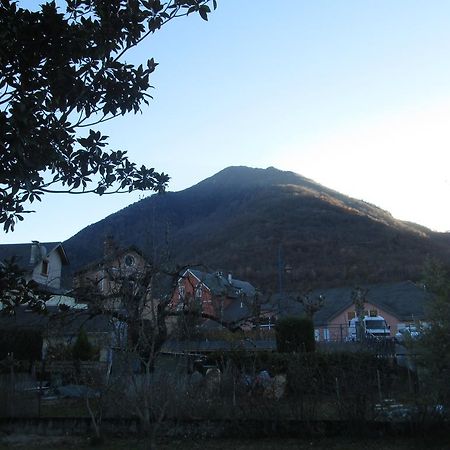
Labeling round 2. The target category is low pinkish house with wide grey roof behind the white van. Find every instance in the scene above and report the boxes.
[281,281,432,341]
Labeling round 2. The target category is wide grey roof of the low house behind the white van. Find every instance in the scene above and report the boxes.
[271,281,433,325]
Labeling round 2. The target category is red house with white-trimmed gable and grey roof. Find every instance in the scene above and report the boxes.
[169,269,256,325]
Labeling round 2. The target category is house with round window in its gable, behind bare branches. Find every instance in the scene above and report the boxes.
[73,236,148,309]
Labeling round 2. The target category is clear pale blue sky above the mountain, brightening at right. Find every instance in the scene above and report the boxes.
[0,0,450,246]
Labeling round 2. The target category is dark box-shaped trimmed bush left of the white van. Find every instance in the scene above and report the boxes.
[275,317,316,353]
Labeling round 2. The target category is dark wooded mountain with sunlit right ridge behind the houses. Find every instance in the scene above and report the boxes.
[64,167,450,290]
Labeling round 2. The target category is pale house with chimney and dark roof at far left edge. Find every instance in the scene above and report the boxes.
[0,241,69,294]
